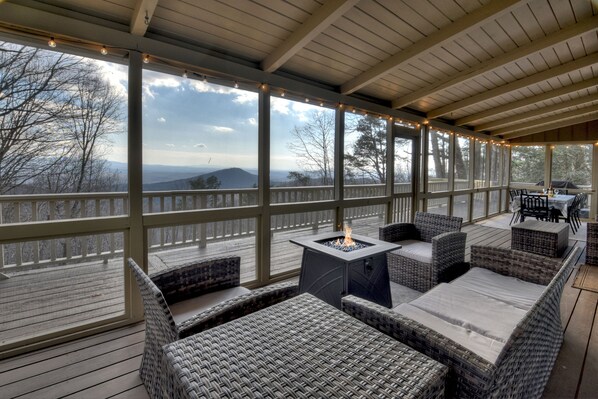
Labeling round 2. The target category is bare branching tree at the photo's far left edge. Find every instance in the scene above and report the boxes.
[0,43,79,194]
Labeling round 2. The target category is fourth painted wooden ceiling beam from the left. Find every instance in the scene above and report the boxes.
[392,15,598,108]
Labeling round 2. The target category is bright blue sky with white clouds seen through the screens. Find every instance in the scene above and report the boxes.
[97,61,342,170]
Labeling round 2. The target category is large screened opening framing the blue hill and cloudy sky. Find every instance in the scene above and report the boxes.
[143,70,258,208]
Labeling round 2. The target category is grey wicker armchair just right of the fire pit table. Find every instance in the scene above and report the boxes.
[379,212,467,292]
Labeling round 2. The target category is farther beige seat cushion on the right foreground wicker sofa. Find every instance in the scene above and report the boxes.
[450,267,546,311]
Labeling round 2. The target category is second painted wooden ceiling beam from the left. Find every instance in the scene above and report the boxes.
[261,0,359,72]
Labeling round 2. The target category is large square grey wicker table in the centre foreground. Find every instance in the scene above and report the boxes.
[164,294,447,398]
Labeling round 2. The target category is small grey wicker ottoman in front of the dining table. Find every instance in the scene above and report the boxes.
[511,220,569,258]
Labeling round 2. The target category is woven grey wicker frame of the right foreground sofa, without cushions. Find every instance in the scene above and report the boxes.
[343,246,581,398]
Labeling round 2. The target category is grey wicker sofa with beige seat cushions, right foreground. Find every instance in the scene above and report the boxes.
[343,246,581,398]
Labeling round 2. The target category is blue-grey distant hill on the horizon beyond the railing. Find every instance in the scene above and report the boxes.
[143,168,257,191]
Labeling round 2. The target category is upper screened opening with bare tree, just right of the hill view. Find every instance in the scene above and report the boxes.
[270,97,335,203]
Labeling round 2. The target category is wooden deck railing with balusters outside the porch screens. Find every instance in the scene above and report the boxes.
[0,184,411,269]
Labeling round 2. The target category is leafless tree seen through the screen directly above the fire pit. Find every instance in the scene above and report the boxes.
[288,110,335,185]
